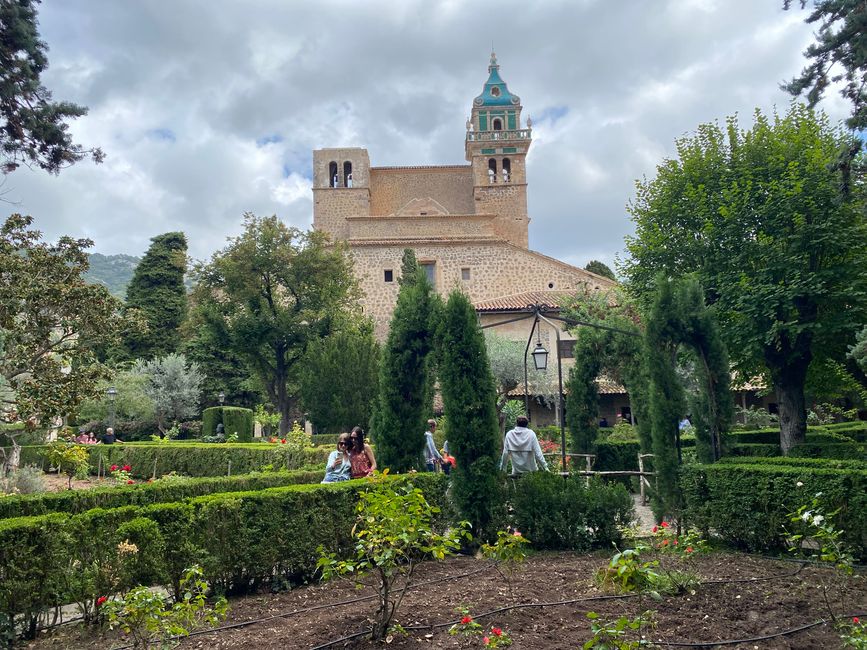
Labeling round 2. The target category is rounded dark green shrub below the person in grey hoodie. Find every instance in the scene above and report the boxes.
[509,472,632,551]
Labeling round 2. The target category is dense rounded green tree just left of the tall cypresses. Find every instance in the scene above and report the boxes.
[299,322,380,433]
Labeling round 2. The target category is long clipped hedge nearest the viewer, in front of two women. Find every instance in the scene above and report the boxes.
[0,474,447,635]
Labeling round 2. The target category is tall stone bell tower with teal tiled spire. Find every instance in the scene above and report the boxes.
[466,52,532,248]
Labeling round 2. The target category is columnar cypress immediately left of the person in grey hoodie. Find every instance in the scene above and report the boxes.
[437,290,501,541]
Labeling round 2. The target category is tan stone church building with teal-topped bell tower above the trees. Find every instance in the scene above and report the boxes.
[313,54,614,338]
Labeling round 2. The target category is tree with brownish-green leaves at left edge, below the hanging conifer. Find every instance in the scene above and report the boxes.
[0,214,135,474]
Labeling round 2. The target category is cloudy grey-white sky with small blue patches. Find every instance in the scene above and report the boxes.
[3,0,848,266]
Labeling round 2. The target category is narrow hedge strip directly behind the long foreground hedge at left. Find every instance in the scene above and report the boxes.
[0,470,323,519]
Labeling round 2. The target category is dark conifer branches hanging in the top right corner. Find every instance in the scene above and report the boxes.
[783,0,867,131]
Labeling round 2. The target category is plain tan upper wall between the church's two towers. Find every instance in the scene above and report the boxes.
[370,165,477,215]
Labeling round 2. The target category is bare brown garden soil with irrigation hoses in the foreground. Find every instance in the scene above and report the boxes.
[27,552,867,650]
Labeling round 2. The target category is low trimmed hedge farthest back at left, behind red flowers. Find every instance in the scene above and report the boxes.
[21,442,331,479]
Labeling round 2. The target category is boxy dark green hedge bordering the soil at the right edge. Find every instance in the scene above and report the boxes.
[681,463,867,558]
